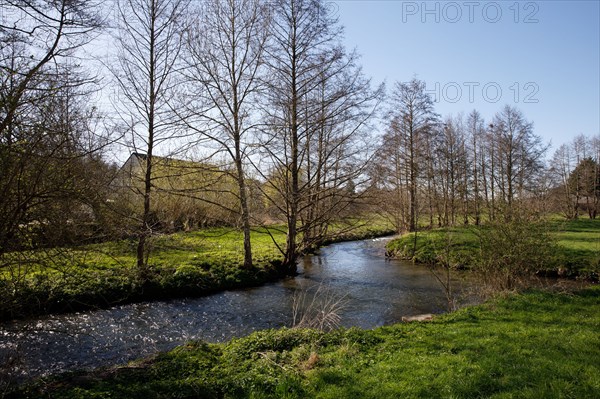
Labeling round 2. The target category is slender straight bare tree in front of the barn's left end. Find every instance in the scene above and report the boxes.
[110,0,189,281]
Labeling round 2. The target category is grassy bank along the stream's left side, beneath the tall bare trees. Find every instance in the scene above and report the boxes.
[0,220,392,319]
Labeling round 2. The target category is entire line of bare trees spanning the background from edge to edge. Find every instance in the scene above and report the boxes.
[0,0,600,281]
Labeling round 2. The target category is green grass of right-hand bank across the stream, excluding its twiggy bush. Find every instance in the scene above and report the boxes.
[387,218,600,279]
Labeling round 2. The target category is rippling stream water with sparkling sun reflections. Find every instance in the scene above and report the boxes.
[0,239,474,377]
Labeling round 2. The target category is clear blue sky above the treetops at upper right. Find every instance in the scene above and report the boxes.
[336,0,600,149]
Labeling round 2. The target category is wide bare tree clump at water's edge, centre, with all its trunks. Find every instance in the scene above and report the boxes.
[257,1,382,272]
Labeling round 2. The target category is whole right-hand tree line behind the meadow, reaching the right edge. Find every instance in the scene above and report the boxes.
[370,79,600,232]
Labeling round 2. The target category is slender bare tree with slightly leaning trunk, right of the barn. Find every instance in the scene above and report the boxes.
[180,0,268,268]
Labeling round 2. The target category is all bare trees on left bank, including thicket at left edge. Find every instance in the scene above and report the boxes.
[0,0,383,280]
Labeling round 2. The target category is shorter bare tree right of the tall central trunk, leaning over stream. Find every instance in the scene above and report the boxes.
[299,53,383,249]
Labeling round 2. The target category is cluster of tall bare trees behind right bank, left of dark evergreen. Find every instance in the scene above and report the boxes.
[372,79,560,231]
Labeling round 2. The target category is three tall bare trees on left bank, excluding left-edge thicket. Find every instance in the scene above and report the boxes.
[111,0,382,273]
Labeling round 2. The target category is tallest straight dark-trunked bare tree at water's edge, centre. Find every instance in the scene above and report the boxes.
[258,0,343,273]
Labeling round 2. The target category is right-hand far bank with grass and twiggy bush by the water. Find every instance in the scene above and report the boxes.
[387,217,600,289]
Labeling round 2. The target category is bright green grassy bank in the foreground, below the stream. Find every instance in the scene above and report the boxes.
[8,287,600,399]
